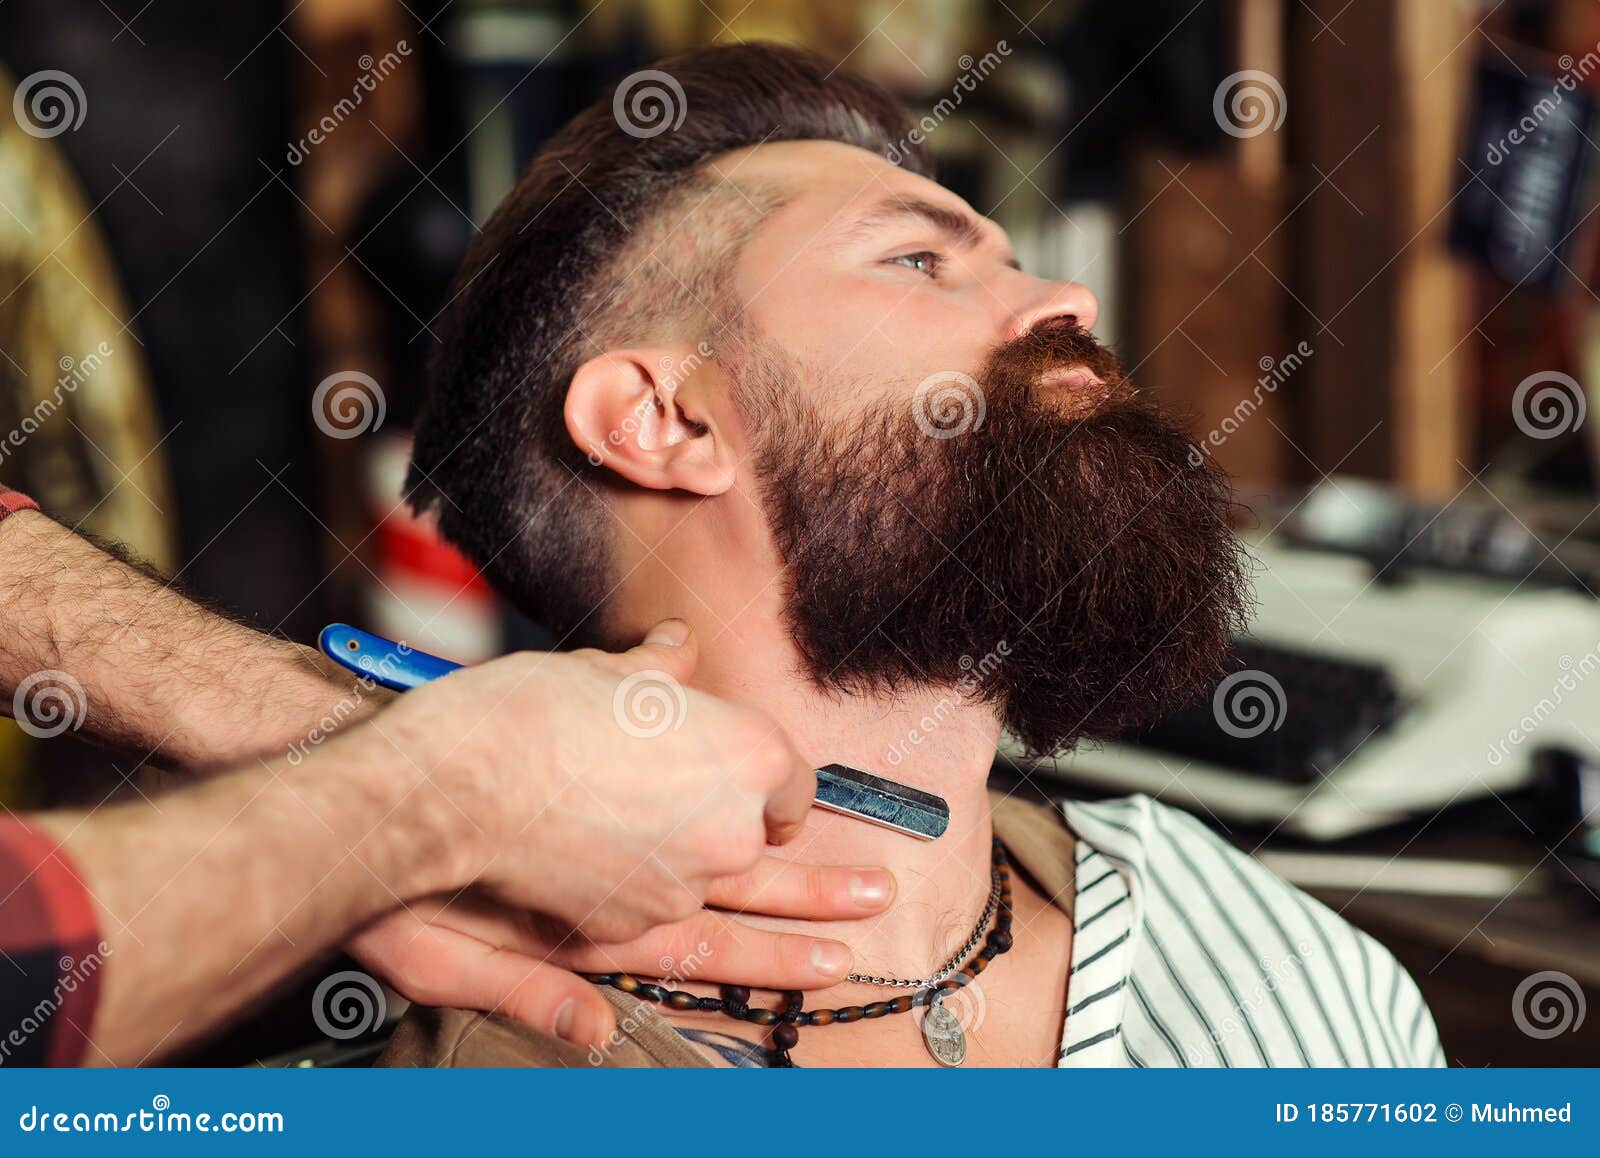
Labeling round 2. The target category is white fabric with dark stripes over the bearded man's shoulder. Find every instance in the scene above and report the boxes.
[1059,795,1445,1067]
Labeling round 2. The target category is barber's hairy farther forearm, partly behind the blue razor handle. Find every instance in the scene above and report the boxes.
[0,512,386,769]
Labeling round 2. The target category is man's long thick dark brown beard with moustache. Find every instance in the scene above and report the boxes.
[739,326,1248,752]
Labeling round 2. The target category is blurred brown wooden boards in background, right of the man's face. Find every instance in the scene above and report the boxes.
[1128,0,1478,501]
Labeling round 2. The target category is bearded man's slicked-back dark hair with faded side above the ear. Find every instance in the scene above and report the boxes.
[406,43,933,646]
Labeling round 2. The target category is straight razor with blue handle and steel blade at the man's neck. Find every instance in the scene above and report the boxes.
[317,624,950,840]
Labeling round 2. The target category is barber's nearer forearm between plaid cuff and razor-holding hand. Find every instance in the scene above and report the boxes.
[29,728,469,1065]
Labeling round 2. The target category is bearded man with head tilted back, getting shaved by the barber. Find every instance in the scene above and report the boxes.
[387,45,1442,1065]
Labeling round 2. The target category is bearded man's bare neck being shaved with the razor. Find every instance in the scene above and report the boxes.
[614,491,1000,1001]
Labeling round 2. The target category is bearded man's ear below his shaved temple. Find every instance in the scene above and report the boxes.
[565,347,734,494]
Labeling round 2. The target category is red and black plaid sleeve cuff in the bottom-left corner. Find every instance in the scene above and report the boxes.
[0,817,110,1068]
